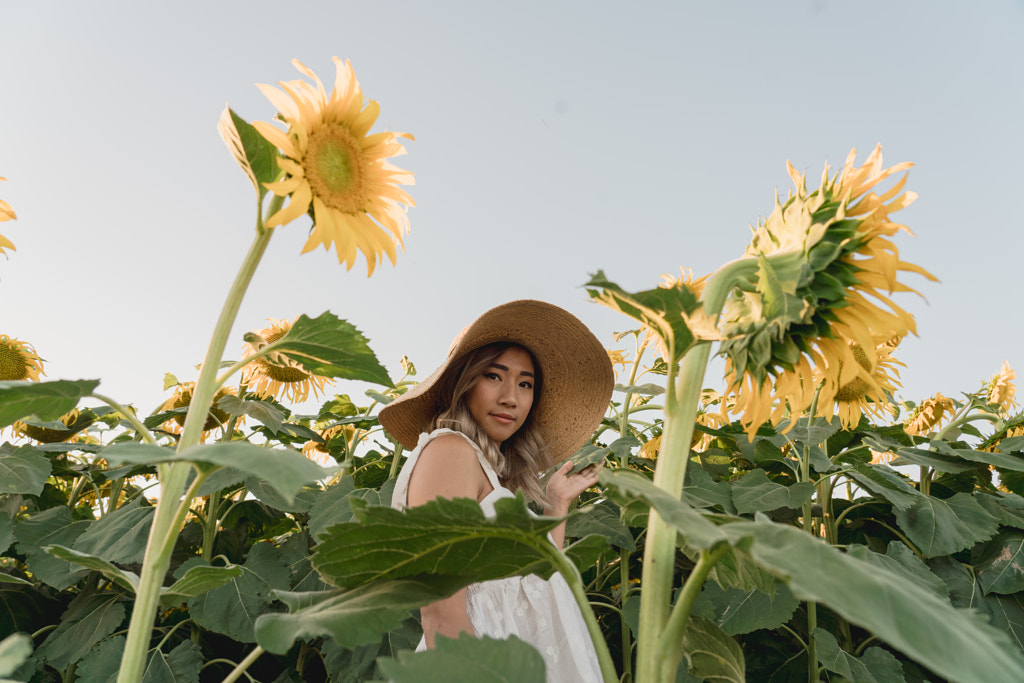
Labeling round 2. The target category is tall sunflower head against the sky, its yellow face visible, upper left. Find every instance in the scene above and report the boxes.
[253,57,416,275]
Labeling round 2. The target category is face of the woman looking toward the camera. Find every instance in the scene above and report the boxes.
[465,346,537,445]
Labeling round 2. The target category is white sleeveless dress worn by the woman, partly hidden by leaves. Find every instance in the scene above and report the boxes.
[391,429,602,683]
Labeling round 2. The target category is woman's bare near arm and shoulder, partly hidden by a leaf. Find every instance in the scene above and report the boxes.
[409,434,492,649]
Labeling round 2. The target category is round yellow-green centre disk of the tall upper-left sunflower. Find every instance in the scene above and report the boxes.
[302,126,366,213]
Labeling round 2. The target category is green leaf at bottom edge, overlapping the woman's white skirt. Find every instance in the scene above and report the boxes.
[379,634,545,683]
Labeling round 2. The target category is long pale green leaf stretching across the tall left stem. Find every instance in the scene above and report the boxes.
[103,441,335,503]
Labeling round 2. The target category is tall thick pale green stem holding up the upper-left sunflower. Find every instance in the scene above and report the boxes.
[118,196,285,683]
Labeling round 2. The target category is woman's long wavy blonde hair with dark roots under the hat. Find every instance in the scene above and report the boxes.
[432,342,548,506]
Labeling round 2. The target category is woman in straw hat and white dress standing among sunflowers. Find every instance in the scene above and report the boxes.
[380,301,613,683]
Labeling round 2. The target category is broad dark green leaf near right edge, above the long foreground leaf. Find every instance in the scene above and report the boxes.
[895,494,998,557]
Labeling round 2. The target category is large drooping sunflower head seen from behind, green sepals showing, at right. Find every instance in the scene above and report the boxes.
[721,145,935,433]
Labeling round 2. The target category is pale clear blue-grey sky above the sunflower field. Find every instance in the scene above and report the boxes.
[0,0,1024,421]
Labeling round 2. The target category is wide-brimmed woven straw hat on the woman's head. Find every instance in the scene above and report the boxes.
[380,299,614,465]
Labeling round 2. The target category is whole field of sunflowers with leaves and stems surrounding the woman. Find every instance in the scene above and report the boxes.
[0,60,1024,683]
